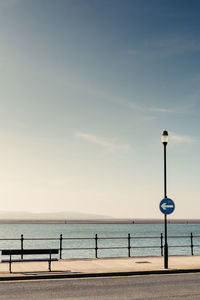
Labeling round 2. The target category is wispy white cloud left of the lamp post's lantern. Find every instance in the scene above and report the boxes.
[75,132,131,152]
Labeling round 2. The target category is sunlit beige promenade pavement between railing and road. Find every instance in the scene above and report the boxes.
[0,256,200,281]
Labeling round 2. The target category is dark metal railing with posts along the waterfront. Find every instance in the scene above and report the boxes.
[0,233,200,259]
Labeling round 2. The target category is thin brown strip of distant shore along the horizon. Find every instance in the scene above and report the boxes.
[0,218,200,224]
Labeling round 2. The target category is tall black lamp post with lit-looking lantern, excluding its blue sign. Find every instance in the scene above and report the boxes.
[162,130,168,269]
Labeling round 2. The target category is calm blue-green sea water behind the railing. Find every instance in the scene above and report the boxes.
[0,224,200,258]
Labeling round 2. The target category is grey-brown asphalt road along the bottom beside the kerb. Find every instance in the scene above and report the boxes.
[0,273,200,300]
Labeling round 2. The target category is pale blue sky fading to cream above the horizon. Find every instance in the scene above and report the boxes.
[0,0,200,219]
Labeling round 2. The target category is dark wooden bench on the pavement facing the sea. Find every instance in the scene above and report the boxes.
[1,249,58,273]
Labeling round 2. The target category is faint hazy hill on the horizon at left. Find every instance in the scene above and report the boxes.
[0,211,112,220]
